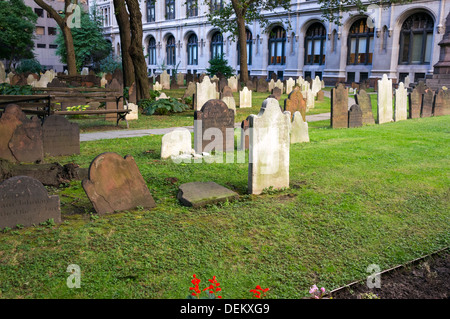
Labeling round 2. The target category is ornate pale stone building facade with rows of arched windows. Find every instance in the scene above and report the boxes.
[90,0,450,84]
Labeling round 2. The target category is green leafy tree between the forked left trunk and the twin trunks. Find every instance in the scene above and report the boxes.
[56,10,112,71]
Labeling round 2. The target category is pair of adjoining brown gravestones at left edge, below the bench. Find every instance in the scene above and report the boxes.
[0,104,80,163]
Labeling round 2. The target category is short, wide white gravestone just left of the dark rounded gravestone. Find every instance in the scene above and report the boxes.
[161,128,192,159]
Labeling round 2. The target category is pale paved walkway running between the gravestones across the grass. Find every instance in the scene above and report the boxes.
[80,113,331,142]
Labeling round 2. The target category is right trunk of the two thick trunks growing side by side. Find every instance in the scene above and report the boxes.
[126,0,150,101]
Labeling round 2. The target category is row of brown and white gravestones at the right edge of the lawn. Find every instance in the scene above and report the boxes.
[331,74,450,128]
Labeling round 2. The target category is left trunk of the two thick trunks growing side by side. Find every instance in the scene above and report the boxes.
[114,0,135,87]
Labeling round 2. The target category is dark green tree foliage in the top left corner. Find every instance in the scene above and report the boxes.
[0,0,38,69]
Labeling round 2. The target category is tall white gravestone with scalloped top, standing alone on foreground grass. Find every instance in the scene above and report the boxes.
[248,98,291,194]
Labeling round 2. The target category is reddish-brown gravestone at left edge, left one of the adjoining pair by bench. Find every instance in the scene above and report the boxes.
[0,104,44,163]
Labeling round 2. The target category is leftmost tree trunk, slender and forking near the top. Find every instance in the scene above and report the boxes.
[34,0,77,75]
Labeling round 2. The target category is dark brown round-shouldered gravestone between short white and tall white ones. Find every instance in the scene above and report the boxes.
[194,99,234,154]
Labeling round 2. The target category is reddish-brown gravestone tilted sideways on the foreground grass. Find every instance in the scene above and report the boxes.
[82,153,156,215]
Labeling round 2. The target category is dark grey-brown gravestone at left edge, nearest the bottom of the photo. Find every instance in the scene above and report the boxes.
[0,176,61,228]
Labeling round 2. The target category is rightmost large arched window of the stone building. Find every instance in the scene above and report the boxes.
[399,12,434,64]
